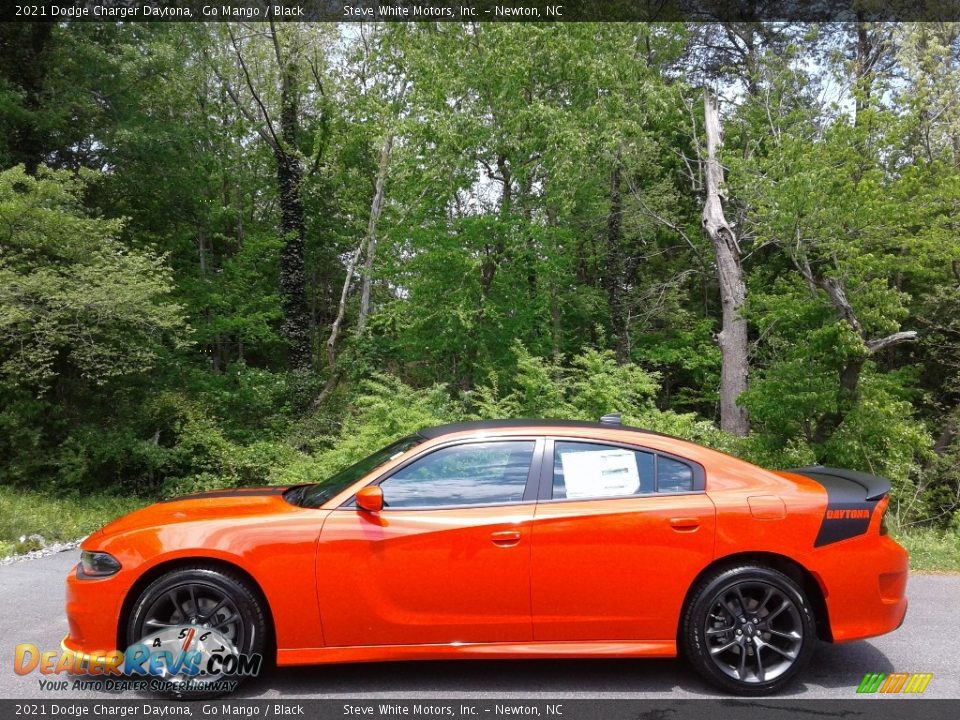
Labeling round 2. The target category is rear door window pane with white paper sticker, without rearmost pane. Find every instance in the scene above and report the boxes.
[553,441,656,500]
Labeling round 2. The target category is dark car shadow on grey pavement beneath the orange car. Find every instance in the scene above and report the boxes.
[236,642,893,699]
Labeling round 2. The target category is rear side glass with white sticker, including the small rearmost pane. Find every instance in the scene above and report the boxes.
[552,440,702,500]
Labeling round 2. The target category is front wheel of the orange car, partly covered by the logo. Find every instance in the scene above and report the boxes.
[124,565,268,699]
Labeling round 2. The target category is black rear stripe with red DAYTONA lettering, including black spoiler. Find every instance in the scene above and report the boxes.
[790,467,890,547]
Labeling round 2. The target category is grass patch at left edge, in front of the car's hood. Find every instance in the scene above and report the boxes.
[0,487,149,557]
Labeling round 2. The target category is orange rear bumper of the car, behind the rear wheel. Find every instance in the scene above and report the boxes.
[815,535,909,643]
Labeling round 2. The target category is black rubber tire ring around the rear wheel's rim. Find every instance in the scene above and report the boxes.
[682,565,817,695]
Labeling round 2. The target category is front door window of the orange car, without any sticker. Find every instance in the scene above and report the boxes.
[380,440,536,509]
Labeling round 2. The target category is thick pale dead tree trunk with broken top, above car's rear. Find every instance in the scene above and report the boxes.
[703,90,750,437]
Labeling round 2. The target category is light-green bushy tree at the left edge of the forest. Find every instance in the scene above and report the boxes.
[0,167,187,480]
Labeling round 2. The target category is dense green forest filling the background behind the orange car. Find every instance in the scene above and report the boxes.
[0,23,960,526]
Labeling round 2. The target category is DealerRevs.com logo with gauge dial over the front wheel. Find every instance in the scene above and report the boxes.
[13,625,263,694]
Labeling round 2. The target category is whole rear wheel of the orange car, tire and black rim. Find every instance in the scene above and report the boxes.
[681,564,817,696]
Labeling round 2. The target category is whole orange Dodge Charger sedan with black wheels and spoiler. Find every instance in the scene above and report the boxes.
[63,415,908,695]
